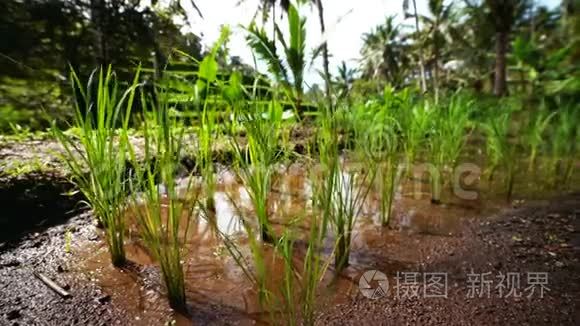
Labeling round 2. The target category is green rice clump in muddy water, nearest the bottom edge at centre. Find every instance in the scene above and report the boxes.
[213,159,332,325]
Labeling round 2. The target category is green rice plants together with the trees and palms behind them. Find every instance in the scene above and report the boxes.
[0,0,580,325]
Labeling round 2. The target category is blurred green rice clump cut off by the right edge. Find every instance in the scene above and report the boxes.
[550,104,580,187]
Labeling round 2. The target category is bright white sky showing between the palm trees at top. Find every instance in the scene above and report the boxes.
[182,0,560,86]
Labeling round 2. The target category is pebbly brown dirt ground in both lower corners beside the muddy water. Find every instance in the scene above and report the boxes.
[0,185,580,325]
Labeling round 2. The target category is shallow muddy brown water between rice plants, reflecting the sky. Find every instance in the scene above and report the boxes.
[72,165,568,325]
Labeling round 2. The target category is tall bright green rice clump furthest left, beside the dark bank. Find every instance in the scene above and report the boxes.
[52,67,139,266]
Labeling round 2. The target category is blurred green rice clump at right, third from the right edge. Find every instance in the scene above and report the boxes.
[482,105,516,201]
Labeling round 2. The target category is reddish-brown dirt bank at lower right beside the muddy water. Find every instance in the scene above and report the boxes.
[319,194,580,325]
